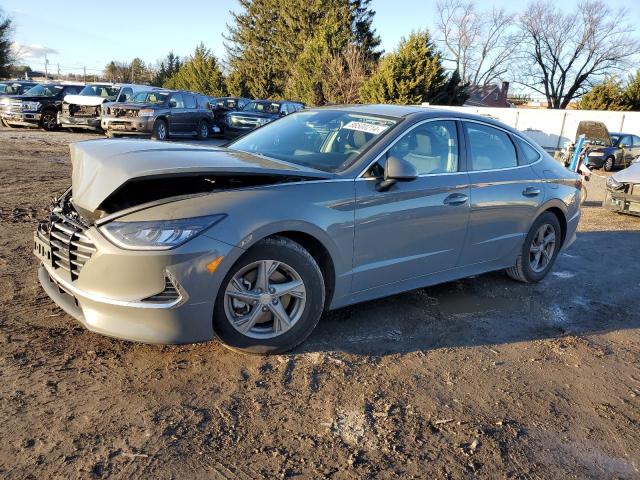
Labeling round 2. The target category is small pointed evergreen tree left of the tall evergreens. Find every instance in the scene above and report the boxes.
[164,43,227,97]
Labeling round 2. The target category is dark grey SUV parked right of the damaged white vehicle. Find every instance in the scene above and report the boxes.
[100,90,213,140]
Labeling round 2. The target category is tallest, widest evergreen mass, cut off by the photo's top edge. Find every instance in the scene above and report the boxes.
[226,0,380,99]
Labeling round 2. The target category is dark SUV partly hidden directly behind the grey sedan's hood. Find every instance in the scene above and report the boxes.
[224,100,304,139]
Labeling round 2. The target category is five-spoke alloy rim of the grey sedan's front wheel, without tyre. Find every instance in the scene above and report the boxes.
[224,260,307,339]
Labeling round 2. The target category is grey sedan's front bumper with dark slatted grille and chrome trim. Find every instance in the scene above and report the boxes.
[34,197,242,344]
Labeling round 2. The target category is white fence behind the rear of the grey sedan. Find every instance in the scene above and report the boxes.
[424,105,640,151]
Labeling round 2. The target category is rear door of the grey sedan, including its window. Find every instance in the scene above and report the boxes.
[460,120,544,266]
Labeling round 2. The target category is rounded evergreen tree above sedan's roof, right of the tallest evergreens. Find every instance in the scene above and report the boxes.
[360,32,464,105]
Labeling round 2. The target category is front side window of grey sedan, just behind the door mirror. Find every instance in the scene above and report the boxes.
[387,120,458,175]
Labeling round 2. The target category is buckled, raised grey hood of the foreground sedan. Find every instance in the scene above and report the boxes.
[70,140,333,213]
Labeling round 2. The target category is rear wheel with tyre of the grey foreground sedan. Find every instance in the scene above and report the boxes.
[506,212,562,283]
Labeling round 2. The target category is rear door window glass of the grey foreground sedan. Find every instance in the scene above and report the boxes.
[464,122,518,170]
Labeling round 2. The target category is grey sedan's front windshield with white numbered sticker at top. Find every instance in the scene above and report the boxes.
[229,110,398,172]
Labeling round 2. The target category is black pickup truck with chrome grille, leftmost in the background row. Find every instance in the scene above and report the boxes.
[0,83,84,130]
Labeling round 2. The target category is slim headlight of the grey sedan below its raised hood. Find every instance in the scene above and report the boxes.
[100,215,226,250]
